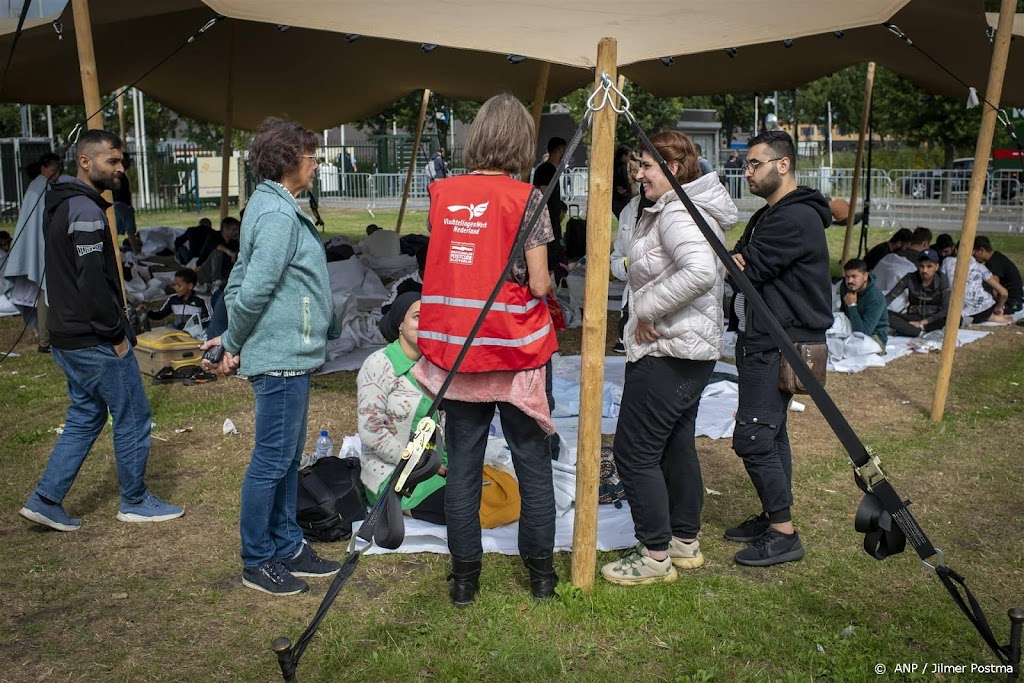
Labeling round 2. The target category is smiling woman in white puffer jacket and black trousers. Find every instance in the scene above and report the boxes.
[601,131,737,586]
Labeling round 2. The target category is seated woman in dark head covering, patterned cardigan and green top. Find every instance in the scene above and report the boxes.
[356,292,447,524]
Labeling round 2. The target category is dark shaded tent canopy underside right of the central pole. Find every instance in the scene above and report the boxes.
[622,0,1024,106]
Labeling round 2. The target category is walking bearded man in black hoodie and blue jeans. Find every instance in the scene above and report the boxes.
[19,130,184,531]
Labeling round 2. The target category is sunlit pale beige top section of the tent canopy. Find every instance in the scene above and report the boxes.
[206,0,907,67]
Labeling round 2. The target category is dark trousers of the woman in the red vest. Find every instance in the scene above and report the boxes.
[443,399,555,562]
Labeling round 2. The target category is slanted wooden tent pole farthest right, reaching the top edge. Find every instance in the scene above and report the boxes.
[932,0,1017,422]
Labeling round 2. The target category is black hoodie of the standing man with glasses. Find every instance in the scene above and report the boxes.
[733,187,833,353]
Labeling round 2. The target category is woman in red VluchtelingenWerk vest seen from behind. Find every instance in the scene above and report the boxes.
[413,94,558,607]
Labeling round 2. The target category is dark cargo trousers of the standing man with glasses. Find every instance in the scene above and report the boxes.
[732,333,793,523]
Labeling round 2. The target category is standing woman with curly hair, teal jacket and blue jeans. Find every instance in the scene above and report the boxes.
[203,119,341,595]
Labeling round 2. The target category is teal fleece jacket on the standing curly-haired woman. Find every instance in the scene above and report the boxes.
[220,180,341,377]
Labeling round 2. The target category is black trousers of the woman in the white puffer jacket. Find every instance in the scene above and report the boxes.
[612,355,715,550]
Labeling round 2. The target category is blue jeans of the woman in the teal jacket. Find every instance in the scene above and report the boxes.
[240,375,310,569]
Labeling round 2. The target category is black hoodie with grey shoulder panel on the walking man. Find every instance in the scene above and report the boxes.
[43,175,125,349]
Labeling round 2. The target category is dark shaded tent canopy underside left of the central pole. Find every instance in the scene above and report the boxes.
[0,0,591,129]
